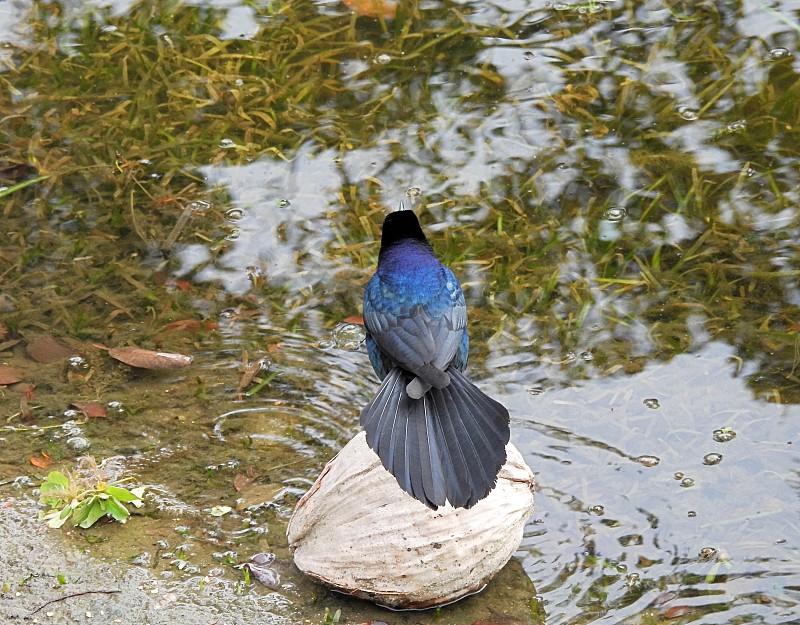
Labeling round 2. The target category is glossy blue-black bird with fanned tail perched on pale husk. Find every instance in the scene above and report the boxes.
[360,206,510,510]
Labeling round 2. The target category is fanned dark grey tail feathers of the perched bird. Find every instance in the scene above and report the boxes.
[361,367,510,510]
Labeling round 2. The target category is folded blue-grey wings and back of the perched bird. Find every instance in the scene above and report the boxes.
[364,274,467,378]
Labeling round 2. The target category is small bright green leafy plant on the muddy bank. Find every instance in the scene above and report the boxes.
[39,458,145,529]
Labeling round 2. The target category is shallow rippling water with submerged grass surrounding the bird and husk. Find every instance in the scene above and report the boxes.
[0,0,800,625]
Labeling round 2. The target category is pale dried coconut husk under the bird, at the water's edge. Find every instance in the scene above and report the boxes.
[286,432,534,608]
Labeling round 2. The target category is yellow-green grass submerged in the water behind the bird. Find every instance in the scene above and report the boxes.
[0,2,800,391]
